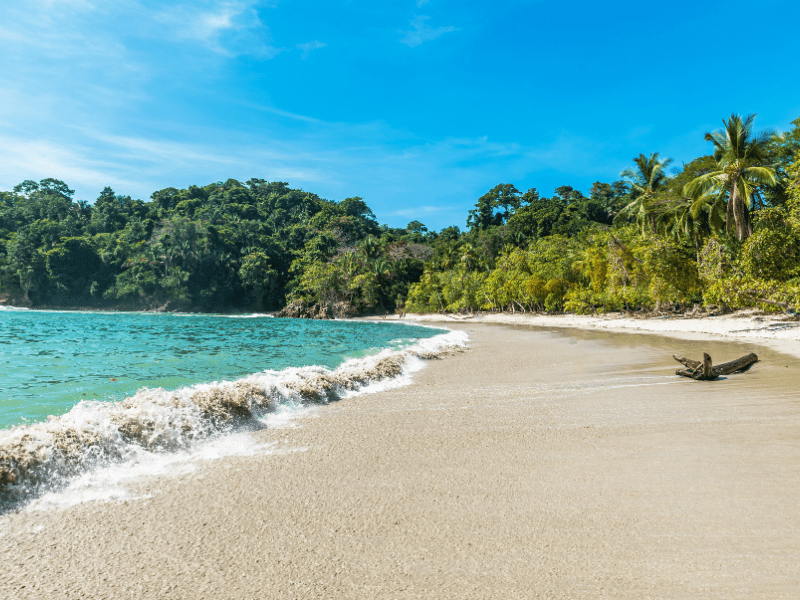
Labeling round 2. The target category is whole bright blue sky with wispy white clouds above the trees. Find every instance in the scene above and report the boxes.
[0,0,800,230]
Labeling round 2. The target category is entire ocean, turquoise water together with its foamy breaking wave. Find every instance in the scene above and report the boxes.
[0,310,466,508]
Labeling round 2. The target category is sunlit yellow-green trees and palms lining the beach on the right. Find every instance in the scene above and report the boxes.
[407,114,800,314]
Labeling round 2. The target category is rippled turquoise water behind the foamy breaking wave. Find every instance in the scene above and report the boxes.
[0,311,441,428]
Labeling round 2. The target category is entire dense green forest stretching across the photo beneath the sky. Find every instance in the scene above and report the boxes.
[0,115,800,317]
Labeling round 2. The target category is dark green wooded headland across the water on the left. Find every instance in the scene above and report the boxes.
[0,179,432,311]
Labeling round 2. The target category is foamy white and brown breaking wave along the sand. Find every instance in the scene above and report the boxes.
[0,331,468,509]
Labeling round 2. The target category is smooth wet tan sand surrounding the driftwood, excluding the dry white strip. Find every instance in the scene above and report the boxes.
[0,323,800,600]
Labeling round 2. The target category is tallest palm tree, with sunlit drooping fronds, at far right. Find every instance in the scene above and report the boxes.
[684,114,777,241]
